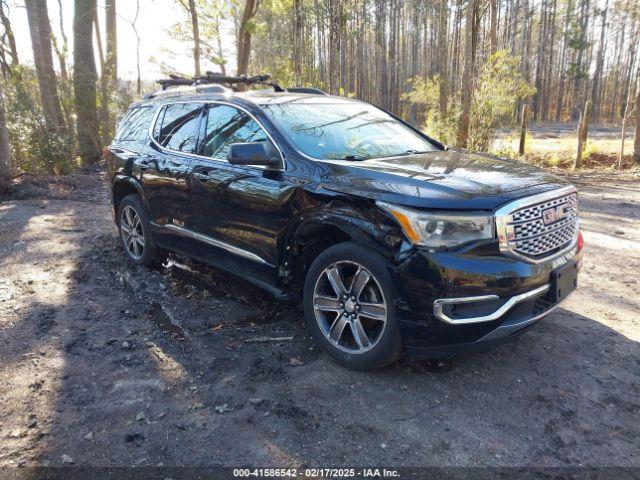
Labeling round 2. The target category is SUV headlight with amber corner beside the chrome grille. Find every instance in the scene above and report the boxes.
[376,202,494,248]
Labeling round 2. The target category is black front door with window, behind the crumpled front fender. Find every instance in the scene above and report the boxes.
[190,104,295,286]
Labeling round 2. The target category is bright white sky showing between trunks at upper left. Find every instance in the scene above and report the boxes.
[8,0,235,81]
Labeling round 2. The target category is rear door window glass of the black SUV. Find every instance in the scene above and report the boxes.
[153,103,204,153]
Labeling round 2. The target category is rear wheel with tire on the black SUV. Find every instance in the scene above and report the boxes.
[117,195,167,267]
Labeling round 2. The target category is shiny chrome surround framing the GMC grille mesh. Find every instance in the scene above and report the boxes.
[494,185,580,264]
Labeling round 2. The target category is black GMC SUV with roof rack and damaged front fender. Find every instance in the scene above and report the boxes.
[108,77,582,370]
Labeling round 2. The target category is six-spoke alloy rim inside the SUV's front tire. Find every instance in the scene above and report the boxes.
[313,260,387,354]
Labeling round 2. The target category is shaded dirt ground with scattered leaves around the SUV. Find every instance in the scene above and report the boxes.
[0,167,640,467]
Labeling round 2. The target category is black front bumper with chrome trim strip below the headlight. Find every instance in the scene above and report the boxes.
[394,242,582,358]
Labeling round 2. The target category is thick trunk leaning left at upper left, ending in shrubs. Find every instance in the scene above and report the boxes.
[25,0,65,132]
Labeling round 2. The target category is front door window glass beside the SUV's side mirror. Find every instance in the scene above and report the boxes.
[203,105,267,160]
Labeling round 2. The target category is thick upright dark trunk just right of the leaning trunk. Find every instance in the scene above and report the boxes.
[73,0,99,165]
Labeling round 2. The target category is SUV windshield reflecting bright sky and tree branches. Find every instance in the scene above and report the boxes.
[262,102,437,160]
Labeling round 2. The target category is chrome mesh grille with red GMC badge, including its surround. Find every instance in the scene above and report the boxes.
[496,188,578,261]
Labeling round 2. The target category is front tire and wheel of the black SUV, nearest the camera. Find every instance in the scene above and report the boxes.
[303,242,402,370]
